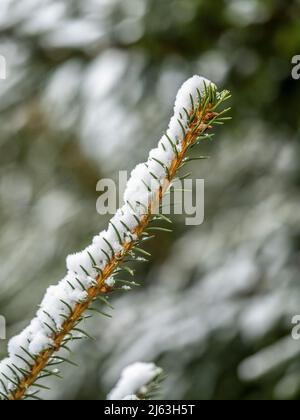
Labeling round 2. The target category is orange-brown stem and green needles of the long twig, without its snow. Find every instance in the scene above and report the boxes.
[0,78,229,400]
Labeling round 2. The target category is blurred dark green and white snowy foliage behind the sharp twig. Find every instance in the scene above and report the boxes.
[0,0,300,399]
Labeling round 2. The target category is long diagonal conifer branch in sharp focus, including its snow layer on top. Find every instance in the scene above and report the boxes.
[0,76,230,400]
